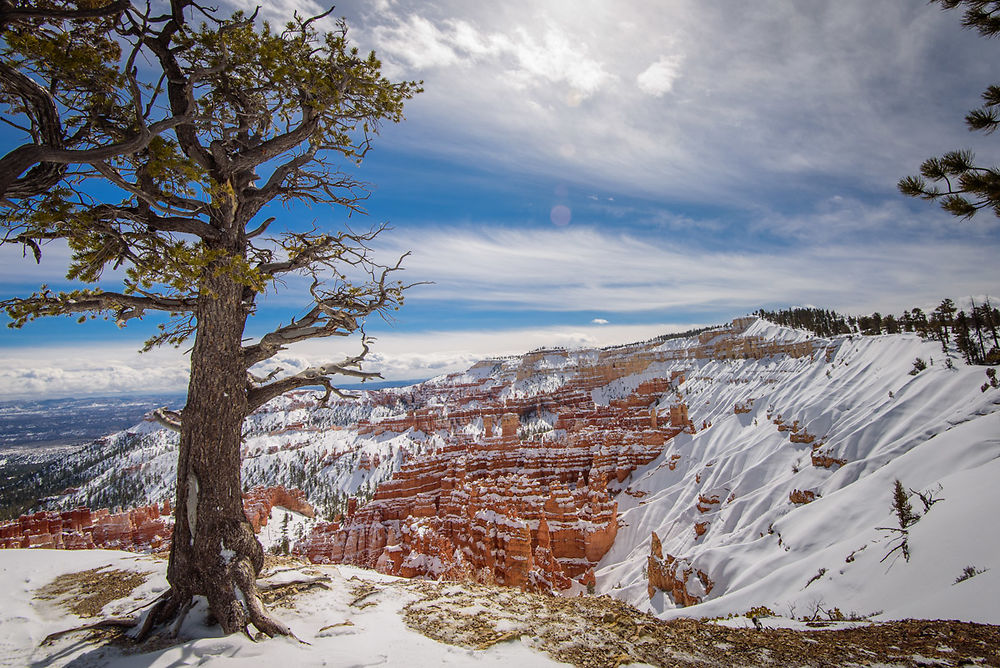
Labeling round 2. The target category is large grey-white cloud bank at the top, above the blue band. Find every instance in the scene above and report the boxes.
[217,0,992,206]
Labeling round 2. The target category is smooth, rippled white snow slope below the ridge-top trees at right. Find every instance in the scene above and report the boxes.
[597,332,1000,623]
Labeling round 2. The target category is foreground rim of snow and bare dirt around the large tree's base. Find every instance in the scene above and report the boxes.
[0,550,1000,668]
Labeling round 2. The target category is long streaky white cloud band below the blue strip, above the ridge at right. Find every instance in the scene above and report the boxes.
[376,222,1000,313]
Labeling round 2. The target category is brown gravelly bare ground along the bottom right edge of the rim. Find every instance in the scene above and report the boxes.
[403,582,1000,668]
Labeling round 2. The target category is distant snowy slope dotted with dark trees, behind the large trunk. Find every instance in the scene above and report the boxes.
[38,388,430,518]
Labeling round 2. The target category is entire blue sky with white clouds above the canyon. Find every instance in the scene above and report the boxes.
[0,0,1000,399]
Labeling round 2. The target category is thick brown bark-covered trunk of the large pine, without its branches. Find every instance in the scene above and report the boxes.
[158,268,289,636]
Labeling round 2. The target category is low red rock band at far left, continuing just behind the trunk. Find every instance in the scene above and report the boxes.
[0,486,315,552]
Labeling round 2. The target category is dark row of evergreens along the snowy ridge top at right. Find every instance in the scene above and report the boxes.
[756,299,1000,365]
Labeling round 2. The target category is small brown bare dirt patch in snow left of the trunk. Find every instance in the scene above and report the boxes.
[35,565,149,617]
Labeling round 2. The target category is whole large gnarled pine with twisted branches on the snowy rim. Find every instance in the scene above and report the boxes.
[0,0,419,635]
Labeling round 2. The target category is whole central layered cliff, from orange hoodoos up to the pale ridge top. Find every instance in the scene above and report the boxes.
[294,318,816,589]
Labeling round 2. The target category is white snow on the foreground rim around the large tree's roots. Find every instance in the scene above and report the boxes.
[0,550,565,668]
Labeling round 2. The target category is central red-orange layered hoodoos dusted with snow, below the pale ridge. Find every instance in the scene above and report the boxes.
[294,366,693,590]
